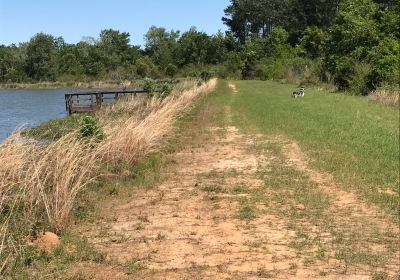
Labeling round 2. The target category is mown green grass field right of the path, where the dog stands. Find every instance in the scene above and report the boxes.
[210,81,400,213]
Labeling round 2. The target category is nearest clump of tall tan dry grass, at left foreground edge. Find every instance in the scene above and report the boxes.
[0,133,98,275]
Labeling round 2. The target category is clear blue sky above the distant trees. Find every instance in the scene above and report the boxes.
[0,0,229,45]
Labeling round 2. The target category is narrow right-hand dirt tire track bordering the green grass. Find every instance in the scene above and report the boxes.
[282,141,400,277]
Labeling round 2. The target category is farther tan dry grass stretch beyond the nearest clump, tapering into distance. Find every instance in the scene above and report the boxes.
[99,80,216,164]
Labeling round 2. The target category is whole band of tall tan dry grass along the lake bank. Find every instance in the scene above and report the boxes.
[0,77,216,275]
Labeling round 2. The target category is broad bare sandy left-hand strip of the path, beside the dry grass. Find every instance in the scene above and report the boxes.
[76,127,297,279]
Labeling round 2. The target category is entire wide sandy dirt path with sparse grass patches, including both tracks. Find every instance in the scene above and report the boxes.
[73,83,399,279]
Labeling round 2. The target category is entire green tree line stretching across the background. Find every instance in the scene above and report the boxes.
[0,0,400,94]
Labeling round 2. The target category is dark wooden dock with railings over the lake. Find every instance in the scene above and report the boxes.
[65,88,148,115]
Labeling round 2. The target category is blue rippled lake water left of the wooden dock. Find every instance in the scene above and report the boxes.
[0,89,85,143]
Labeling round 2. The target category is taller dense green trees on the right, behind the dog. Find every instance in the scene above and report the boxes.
[222,0,400,94]
